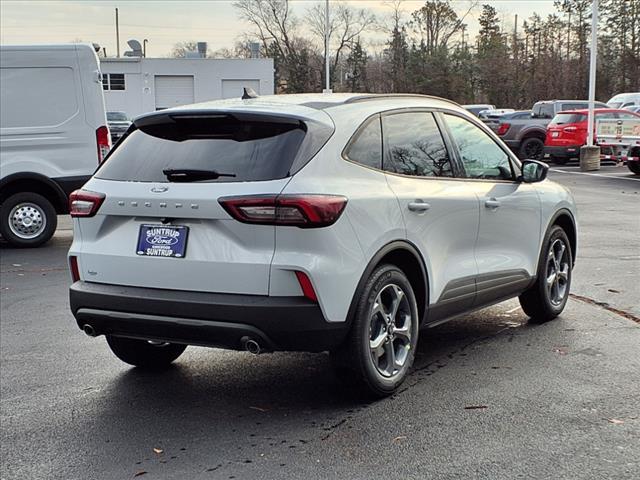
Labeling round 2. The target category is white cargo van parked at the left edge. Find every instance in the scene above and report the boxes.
[0,44,111,247]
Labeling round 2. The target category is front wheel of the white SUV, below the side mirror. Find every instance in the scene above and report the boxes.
[519,225,573,323]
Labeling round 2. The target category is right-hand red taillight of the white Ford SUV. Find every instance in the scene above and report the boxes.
[218,195,347,228]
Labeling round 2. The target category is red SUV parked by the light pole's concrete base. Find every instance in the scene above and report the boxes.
[544,108,640,164]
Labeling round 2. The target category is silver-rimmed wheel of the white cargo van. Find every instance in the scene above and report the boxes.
[0,192,58,247]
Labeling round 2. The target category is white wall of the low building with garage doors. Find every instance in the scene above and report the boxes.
[100,57,274,117]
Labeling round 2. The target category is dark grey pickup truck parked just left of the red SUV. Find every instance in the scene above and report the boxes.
[495,100,607,160]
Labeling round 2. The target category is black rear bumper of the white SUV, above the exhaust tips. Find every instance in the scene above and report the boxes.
[69,281,348,352]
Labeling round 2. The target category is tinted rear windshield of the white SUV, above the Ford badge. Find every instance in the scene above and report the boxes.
[95,115,318,182]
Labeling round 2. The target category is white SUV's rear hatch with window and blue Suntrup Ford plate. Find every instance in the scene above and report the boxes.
[71,106,333,295]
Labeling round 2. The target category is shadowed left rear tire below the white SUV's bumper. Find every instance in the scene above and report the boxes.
[106,335,187,370]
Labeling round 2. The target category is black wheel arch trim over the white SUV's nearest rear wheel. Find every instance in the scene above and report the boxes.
[347,240,429,325]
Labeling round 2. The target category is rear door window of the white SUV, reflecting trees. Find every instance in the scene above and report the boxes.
[382,112,453,177]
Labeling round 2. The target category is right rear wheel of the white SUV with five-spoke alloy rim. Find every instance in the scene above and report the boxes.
[331,265,419,397]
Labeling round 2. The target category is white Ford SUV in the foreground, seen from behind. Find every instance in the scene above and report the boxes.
[69,94,577,395]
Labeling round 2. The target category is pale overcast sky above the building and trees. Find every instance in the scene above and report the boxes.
[0,0,554,57]
